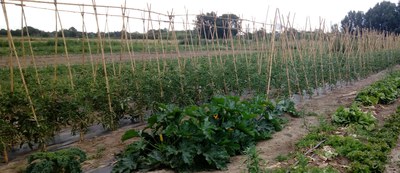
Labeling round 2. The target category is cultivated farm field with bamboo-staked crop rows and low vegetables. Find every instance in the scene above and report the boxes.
[0,1,400,173]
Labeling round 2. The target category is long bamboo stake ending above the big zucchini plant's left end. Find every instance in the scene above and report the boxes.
[92,0,113,112]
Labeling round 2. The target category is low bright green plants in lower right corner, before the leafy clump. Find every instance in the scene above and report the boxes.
[290,107,400,172]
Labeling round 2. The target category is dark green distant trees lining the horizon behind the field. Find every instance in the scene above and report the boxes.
[0,1,400,39]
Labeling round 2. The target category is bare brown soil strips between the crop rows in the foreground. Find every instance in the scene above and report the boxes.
[0,66,400,173]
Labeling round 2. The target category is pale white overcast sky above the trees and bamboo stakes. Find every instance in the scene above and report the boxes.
[0,0,398,32]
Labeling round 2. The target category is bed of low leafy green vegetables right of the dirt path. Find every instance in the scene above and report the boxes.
[275,71,400,172]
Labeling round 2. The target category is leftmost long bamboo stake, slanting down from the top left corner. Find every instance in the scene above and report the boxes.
[1,0,40,127]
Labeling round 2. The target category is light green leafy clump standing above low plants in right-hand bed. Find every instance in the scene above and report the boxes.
[332,104,376,130]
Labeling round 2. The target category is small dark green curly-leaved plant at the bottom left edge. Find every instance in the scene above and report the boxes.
[26,148,86,173]
